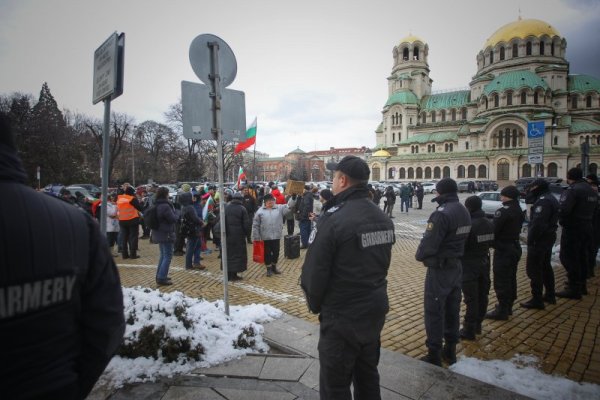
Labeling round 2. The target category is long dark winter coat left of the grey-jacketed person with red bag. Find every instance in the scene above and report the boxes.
[225,199,251,272]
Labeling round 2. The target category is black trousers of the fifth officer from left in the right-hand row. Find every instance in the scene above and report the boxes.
[560,224,593,290]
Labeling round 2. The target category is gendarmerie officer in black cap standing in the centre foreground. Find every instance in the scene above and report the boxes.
[301,156,395,399]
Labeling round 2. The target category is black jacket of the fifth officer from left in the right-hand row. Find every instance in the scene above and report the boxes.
[558,180,598,228]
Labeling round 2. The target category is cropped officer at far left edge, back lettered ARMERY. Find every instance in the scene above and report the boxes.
[0,116,125,399]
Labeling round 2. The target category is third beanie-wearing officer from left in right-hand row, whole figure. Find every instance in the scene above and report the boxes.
[485,185,525,320]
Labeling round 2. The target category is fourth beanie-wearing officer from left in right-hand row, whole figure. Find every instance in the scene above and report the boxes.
[521,178,558,310]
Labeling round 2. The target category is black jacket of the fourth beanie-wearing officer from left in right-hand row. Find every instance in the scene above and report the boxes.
[527,191,558,246]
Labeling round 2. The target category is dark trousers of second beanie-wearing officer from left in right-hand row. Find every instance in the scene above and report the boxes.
[462,259,491,325]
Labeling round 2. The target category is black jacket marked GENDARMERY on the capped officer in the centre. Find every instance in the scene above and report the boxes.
[300,185,395,320]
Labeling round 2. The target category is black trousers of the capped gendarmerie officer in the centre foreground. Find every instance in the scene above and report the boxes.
[318,312,385,400]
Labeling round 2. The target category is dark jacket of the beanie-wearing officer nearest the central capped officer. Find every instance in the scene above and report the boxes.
[415,193,471,267]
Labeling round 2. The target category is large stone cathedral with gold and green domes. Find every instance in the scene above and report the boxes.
[367,18,600,184]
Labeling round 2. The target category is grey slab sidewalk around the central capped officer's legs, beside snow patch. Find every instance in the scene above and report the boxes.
[101,315,527,400]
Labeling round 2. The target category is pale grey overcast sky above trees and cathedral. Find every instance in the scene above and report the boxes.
[0,0,600,157]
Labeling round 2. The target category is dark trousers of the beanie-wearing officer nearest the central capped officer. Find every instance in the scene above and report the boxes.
[424,263,462,351]
